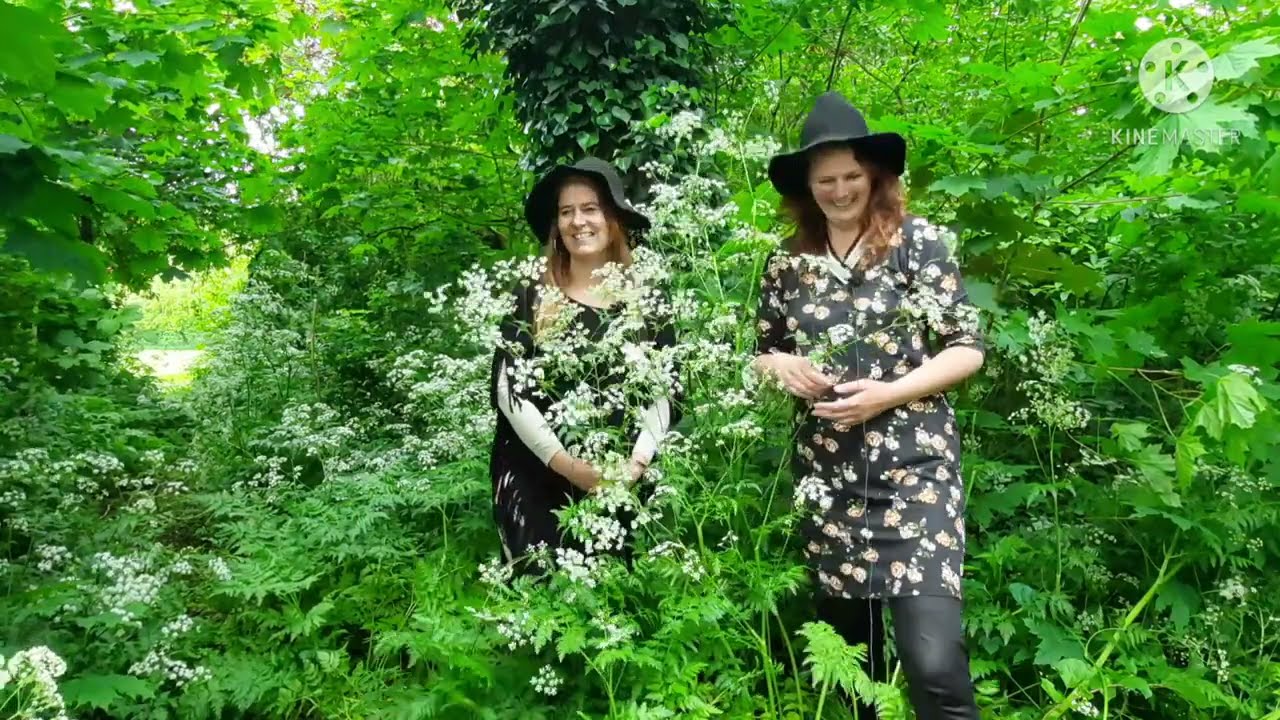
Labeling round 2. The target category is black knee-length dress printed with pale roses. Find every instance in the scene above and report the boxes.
[758,217,984,598]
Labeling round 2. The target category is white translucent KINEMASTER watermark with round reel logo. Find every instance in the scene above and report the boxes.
[1111,37,1240,146]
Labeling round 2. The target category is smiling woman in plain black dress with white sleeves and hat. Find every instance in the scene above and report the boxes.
[489,158,673,570]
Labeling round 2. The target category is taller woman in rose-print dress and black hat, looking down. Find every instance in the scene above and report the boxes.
[756,92,984,720]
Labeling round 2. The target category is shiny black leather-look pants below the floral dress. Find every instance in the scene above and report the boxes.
[818,596,978,720]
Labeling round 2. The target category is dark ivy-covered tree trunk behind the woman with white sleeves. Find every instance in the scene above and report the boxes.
[457,0,728,181]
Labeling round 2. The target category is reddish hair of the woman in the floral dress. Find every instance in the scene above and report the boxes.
[781,146,906,269]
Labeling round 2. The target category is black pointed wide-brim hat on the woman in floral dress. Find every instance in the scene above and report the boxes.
[769,92,906,196]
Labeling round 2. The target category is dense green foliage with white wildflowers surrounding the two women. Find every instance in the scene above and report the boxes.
[0,0,1280,720]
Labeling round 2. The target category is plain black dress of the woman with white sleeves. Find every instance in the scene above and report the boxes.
[489,278,677,561]
